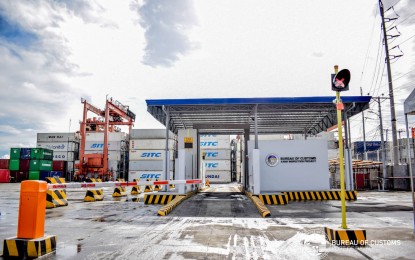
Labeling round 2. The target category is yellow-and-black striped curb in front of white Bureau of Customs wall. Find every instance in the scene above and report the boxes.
[283,190,357,201]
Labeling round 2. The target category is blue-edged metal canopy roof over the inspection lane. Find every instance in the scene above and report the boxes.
[146,96,371,135]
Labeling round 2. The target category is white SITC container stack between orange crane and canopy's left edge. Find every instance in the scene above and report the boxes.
[128,129,177,181]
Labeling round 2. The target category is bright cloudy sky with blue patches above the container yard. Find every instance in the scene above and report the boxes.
[0,0,415,157]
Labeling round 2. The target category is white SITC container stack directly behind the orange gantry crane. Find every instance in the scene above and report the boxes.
[85,132,128,179]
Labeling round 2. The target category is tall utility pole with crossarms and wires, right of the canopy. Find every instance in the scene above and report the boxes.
[379,0,399,165]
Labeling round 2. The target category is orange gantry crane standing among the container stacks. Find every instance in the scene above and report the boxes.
[75,98,135,180]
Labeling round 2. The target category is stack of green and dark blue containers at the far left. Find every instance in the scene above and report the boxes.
[9,148,53,182]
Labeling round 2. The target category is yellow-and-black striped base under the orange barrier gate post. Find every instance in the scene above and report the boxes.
[3,236,56,259]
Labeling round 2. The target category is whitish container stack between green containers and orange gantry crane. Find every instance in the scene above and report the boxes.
[37,133,80,180]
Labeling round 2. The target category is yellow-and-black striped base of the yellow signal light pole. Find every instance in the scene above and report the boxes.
[324,227,367,247]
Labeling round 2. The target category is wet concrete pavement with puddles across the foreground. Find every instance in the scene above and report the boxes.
[0,184,415,259]
